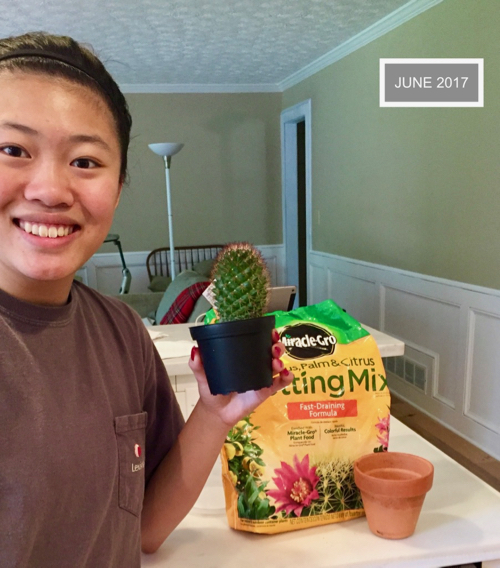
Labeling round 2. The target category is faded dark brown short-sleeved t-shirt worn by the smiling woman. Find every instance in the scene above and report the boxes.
[0,282,184,568]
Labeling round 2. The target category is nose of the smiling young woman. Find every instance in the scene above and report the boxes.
[24,161,74,207]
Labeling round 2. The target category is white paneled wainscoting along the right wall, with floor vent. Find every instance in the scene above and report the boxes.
[308,251,500,459]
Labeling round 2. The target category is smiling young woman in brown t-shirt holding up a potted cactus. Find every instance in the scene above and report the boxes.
[0,33,293,568]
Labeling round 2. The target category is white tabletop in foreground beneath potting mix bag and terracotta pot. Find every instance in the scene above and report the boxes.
[142,418,500,568]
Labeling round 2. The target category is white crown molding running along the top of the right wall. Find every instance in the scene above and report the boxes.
[278,0,443,91]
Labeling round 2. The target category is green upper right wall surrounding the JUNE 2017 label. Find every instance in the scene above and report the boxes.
[283,0,500,288]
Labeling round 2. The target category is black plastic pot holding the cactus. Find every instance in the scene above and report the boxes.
[190,316,275,394]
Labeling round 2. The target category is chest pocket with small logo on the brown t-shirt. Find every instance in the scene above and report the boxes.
[115,412,148,517]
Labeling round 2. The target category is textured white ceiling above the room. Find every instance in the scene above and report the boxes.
[0,0,428,92]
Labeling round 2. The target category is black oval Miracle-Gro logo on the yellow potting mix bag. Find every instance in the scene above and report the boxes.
[280,323,337,359]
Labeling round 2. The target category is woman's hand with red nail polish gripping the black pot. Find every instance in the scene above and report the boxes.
[189,330,293,430]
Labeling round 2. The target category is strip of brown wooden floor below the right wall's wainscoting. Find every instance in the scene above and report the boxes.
[391,394,500,491]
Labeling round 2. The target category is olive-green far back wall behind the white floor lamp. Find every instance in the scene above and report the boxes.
[100,93,282,252]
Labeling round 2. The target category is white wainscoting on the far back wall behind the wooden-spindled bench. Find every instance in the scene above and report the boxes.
[78,245,286,294]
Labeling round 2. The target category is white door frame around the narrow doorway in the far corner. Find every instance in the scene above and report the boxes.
[281,99,312,305]
